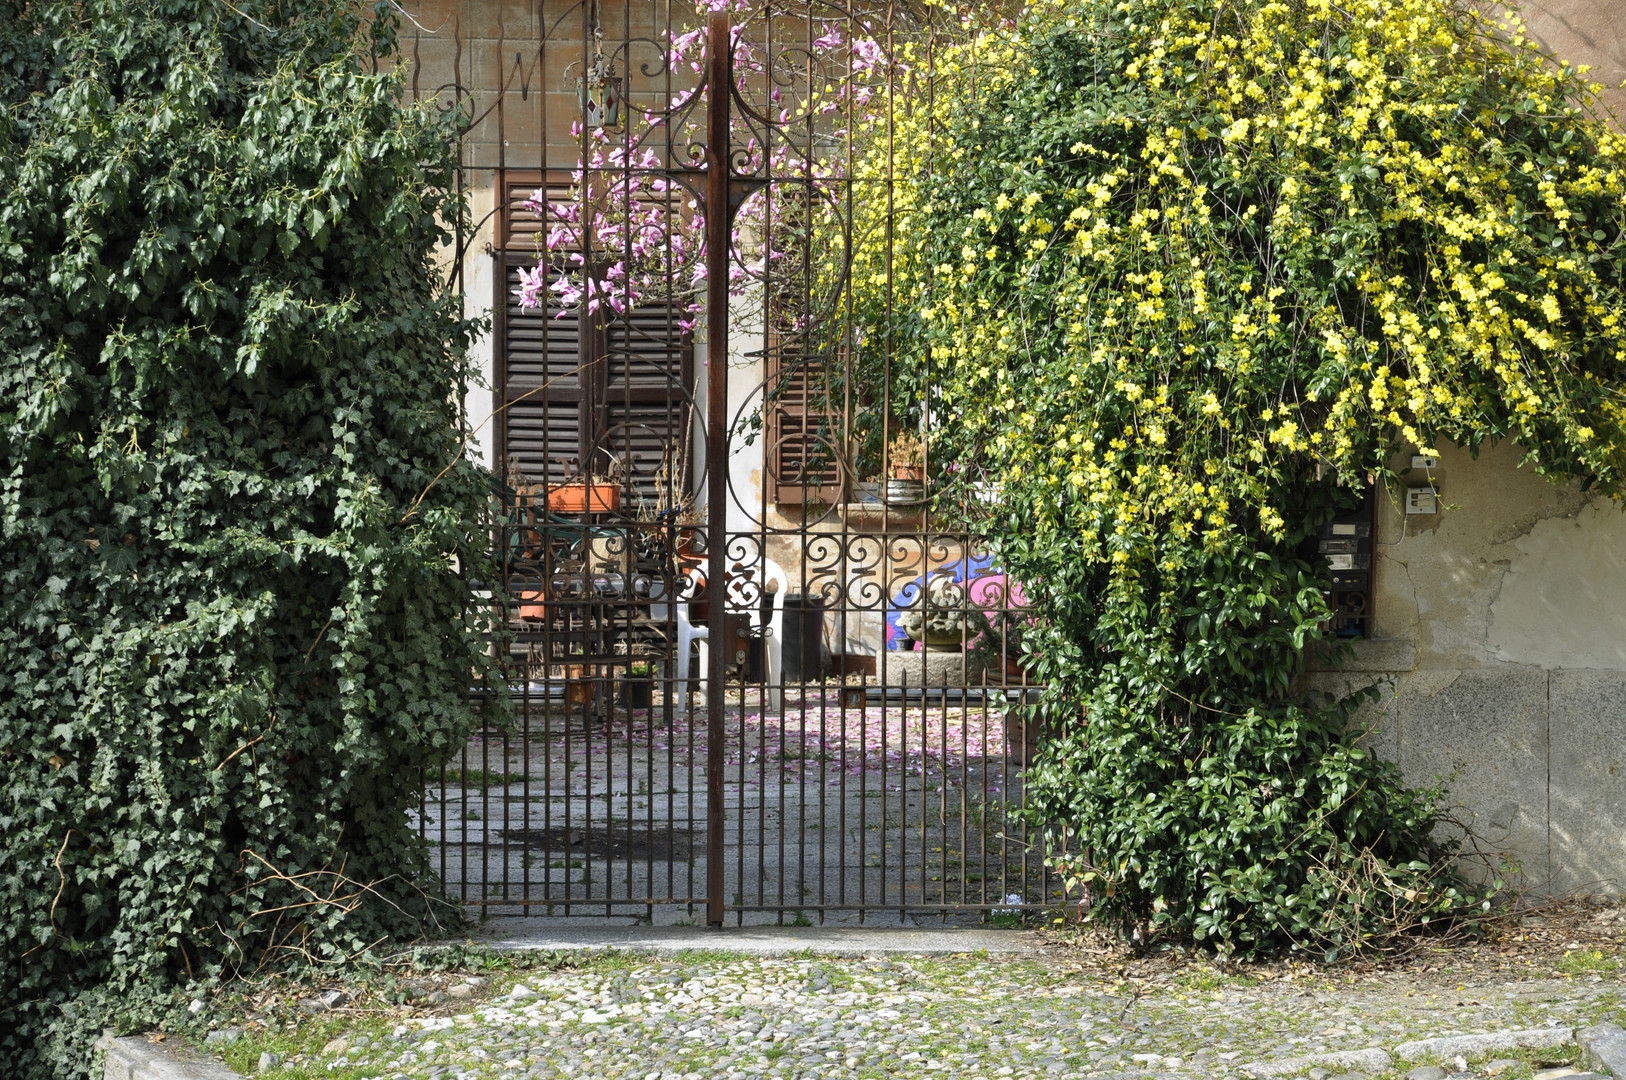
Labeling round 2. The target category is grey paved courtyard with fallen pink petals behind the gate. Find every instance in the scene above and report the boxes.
[421,691,1062,925]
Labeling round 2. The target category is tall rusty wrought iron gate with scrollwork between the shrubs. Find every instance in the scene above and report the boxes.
[405,0,1065,924]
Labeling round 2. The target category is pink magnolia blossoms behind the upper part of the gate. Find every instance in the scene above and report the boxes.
[514,0,889,330]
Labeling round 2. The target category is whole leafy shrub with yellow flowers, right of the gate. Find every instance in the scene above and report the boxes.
[854,0,1626,950]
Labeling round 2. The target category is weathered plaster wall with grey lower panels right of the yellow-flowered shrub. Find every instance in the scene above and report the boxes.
[1309,444,1626,891]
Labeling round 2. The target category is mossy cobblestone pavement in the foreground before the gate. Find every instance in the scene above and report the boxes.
[211,919,1626,1080]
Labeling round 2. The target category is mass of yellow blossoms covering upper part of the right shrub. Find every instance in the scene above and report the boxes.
[850,0,1626,564]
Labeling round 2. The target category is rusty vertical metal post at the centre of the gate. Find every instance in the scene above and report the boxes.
[706,6,733,927]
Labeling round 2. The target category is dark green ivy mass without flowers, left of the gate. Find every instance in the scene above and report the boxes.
[0,0,486,1077]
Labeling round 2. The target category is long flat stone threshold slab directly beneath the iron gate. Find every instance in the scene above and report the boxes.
[458,919,1042,956]
